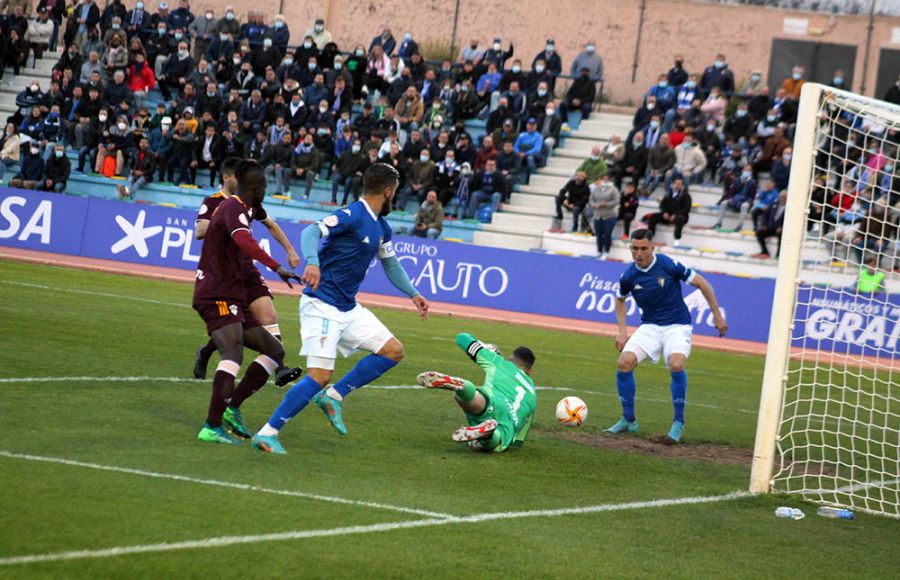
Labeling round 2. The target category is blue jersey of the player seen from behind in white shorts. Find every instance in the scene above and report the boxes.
[303,200,394,312]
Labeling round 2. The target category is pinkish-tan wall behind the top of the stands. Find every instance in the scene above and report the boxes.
[176,0,900,104]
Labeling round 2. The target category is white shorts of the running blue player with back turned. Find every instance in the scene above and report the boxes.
[300,294,394,370]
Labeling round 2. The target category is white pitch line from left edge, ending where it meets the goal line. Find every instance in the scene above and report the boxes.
[0,450,456,519]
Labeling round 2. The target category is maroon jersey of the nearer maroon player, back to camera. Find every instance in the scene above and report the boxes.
[194,196,252,306]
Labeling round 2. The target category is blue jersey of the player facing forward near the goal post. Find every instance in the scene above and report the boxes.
[619,254,696,326]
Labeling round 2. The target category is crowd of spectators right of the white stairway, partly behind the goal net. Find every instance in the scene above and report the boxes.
[556,54,900,264]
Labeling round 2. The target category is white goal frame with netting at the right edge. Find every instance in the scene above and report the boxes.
[751,84,900,517]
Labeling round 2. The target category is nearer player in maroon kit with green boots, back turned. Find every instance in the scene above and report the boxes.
[193,161,300,445]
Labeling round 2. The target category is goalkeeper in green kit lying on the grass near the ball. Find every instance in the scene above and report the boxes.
[418,333,537,453]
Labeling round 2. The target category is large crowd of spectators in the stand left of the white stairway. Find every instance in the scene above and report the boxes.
[0,0,603,235]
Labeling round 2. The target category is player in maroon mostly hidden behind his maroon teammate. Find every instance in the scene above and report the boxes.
[194,158,302,387]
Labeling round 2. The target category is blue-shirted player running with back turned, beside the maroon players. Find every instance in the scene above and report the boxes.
[253,163,428,453]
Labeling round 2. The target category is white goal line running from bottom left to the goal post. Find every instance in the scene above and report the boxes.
[0,491,751,566]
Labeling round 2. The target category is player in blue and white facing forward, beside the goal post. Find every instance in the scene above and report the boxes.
[607,230,728,442]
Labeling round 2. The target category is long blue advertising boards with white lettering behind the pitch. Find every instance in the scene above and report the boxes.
[0,188,900,356]
